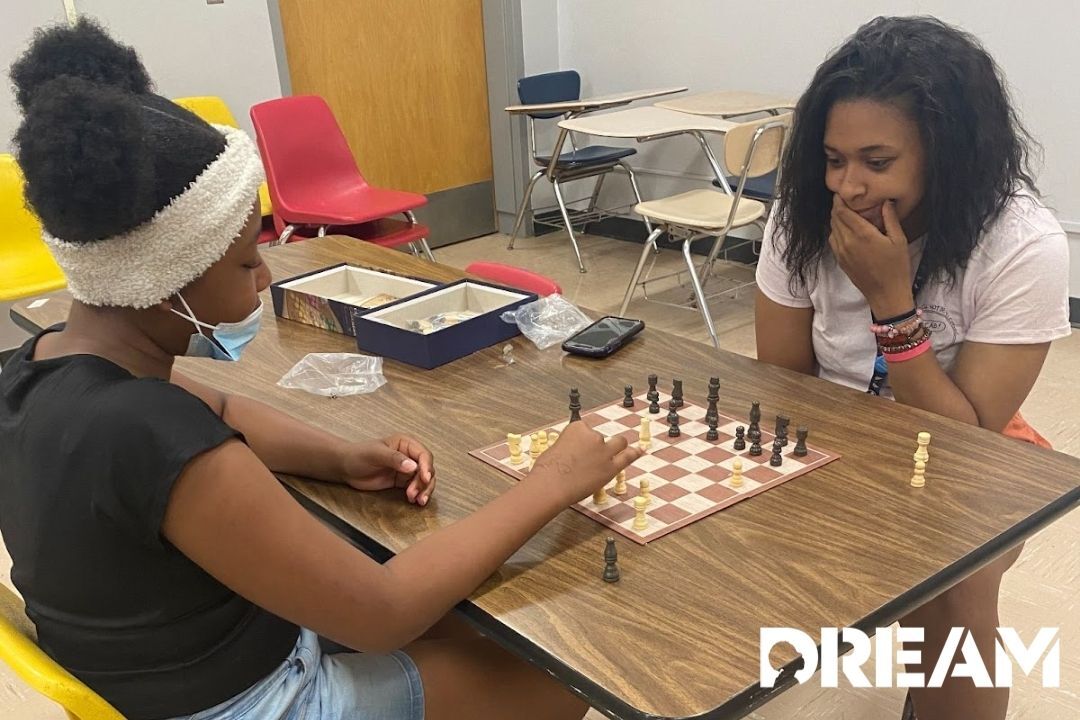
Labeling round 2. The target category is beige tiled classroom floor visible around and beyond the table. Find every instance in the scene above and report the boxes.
[0,232,1080,720]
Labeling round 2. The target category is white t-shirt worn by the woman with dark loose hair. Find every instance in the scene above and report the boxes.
[757,193,1070,396]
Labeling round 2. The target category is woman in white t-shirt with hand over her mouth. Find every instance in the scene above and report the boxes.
[756,12,1069,720]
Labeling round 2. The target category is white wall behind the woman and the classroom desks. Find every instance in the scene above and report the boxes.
[557,0,1080,296]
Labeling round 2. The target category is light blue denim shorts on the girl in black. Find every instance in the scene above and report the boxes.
[170,629,423,720]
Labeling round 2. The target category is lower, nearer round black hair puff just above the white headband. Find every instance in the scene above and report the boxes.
[15,76,161,243]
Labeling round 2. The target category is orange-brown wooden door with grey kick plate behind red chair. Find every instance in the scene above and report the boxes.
[279,0,495,244]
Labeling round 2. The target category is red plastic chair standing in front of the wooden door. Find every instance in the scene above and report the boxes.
[251,95,434,260]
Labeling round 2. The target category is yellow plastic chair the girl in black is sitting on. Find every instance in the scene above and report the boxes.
[0,584,124,720]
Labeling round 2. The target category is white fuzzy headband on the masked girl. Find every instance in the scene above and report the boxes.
[42,125,264,308]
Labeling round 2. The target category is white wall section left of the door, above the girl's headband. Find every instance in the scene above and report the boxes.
[63,0,281,136]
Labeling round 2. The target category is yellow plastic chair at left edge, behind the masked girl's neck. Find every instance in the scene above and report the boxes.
[0,154,67,302]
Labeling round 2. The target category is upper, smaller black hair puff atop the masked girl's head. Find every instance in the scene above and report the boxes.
[11,18,151,109]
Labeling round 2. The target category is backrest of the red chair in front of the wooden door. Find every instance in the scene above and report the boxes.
[251,95,367,220]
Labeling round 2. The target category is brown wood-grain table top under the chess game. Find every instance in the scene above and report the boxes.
[12,237,1080,719]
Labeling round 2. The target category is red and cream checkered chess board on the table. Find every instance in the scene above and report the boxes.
[469,393,840,545]
